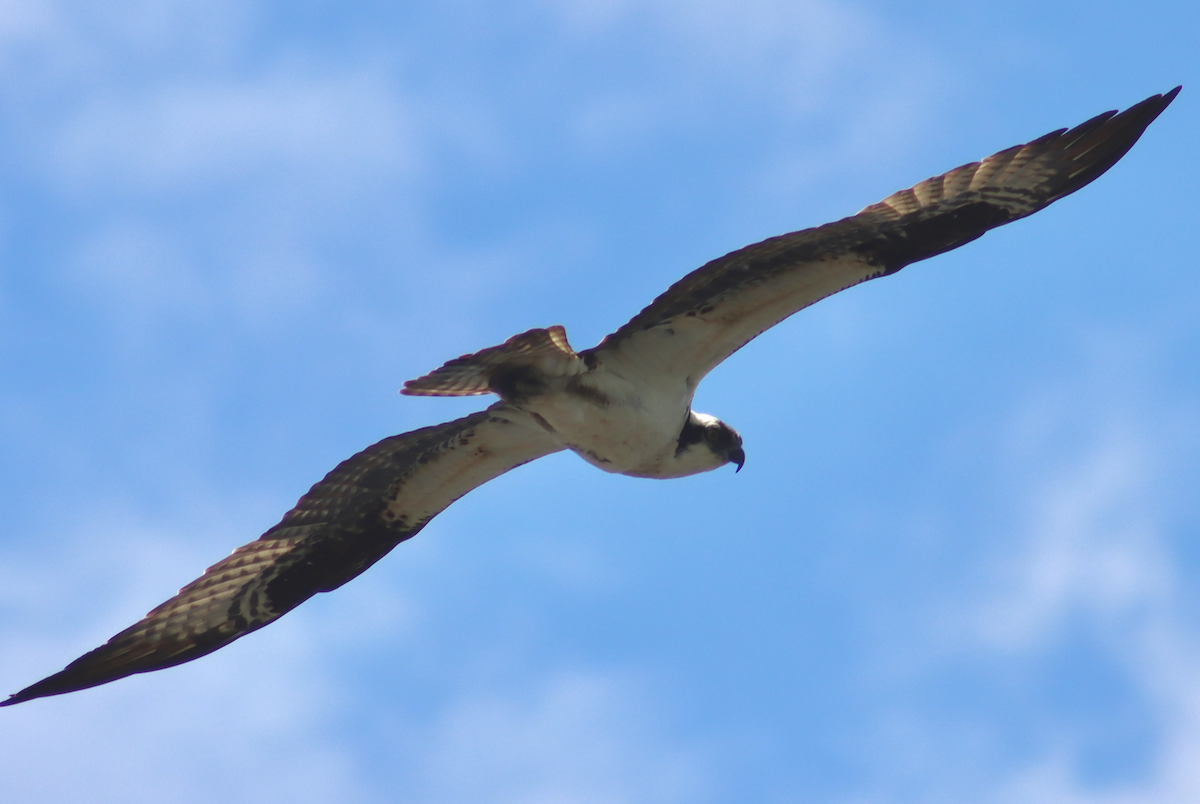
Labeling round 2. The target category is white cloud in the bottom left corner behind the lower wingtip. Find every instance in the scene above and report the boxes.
[0,505,362,804]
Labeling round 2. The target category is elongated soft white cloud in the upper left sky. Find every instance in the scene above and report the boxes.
[54,70,419,196]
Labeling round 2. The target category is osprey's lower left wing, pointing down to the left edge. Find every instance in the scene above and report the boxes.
[0,402,563,706]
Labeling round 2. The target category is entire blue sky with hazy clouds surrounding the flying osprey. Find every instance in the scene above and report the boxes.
[0,0,1200,804]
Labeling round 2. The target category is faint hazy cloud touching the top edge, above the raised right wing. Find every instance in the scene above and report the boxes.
[552,0,941,126]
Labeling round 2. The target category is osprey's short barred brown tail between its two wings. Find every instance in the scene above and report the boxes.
[401,325,586,398]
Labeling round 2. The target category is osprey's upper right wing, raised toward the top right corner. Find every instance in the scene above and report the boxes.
[580,88,1180,389]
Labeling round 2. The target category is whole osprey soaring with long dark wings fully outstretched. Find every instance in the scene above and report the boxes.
[0,88,1180,706]
